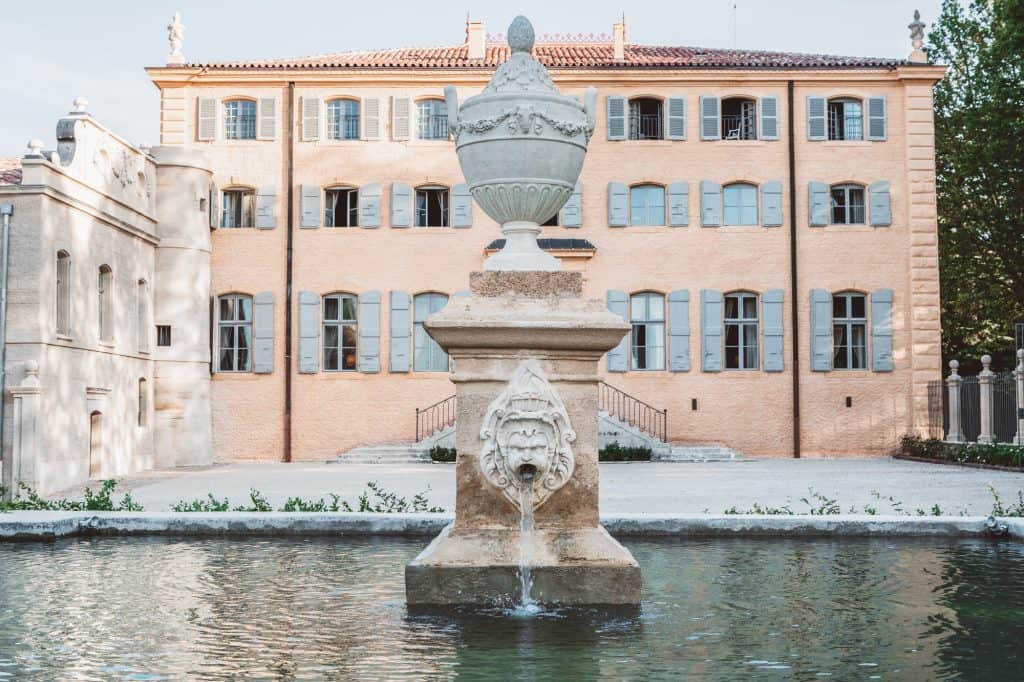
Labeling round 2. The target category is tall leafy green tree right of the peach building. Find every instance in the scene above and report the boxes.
[928,0,1024,369]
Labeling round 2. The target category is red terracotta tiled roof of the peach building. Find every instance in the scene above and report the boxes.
[188,42,908,69]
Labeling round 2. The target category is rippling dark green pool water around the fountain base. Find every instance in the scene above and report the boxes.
[0,538,1024,680]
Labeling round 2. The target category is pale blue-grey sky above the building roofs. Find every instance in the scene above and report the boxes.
[0,0,941,157]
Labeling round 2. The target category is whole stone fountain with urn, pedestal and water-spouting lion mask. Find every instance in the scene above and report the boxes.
[406,16,641,608]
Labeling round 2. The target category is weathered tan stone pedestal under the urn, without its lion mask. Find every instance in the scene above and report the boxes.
[406,271,641,605]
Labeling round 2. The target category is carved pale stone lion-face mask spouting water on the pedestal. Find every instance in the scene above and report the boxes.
[480,359,575,509]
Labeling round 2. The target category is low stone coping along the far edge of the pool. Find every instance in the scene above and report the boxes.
[0,511,1024,542]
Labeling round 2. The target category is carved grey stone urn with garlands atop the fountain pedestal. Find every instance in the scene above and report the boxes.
[444,16,597,270]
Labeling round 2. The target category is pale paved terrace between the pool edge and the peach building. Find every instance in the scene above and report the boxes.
[53,458,1024,515]
